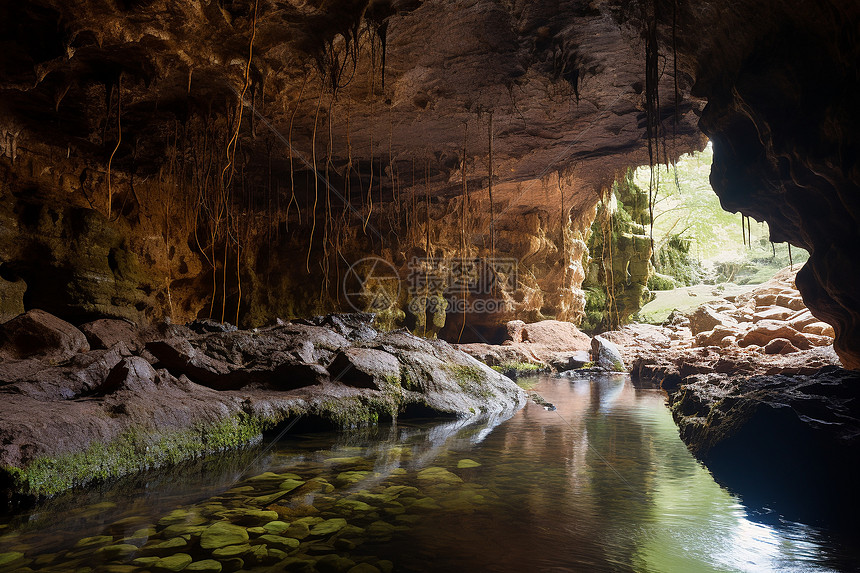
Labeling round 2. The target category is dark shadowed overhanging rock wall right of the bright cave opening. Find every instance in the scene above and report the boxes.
[664,1,860,368]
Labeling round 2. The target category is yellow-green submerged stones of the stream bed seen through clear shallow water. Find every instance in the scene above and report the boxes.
[0,416,505,573]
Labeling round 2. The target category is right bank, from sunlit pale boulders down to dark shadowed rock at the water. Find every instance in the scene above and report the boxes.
[606,271,860,523]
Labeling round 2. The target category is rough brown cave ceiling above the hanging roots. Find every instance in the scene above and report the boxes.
[0,0,704,210]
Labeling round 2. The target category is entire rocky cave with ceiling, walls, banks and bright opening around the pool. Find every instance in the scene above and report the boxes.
[0,0,860,570]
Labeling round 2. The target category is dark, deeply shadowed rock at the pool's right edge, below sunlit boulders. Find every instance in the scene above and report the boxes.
[669,367,860,523]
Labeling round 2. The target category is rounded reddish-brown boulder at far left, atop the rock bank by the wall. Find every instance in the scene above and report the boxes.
[0,309,90,362]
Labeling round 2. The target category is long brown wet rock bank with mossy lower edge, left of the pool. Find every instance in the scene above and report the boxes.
[0,312,525,495]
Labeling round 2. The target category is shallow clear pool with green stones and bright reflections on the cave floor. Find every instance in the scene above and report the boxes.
[0,376,860,573]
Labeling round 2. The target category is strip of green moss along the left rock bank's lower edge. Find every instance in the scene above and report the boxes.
[0,412,281,496]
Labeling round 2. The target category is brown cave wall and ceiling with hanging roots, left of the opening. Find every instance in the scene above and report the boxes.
[0,0,704,340]
